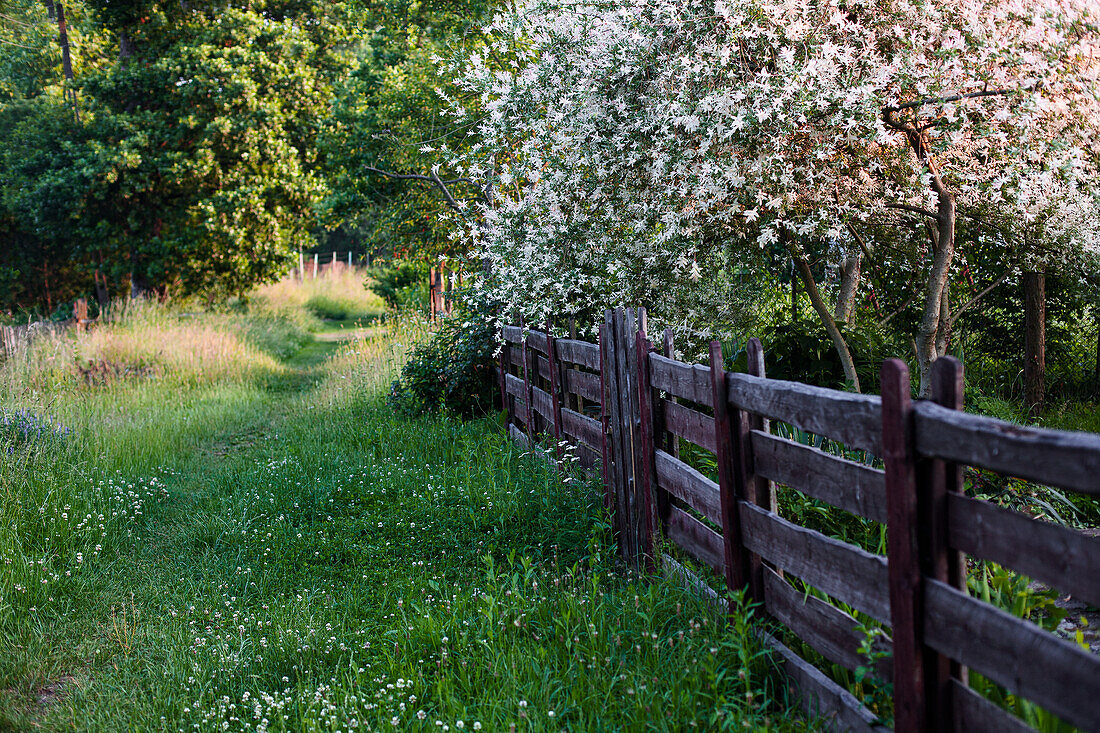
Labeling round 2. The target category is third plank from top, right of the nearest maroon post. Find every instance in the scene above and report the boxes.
[924,579,1100,730]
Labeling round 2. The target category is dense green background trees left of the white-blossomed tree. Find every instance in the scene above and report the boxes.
[0,0,484,310]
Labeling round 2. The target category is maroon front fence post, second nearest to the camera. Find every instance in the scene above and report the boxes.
[711,341,749,603]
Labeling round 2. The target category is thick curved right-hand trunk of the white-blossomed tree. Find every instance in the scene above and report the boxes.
[916,191,955,397]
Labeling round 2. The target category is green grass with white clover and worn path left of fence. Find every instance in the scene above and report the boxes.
[0,275,809,731]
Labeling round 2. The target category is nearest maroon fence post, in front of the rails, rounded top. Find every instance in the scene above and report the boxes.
[880,359,930,733]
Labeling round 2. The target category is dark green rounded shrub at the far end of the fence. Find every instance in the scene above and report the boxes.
[391,313,495,417]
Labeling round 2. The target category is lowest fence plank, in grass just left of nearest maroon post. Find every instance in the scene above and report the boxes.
[762,634,883,733]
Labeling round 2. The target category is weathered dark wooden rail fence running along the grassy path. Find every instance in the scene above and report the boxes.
[498,309,1100,731]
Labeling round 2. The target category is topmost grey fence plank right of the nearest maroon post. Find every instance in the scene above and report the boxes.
[913,402,1100,496]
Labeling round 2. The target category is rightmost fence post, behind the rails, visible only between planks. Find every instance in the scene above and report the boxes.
[917,357,968,730]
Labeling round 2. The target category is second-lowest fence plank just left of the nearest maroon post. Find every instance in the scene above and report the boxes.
[762,567,893,680]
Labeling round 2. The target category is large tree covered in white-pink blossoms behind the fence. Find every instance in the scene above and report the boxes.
[448,0,1100,390]
